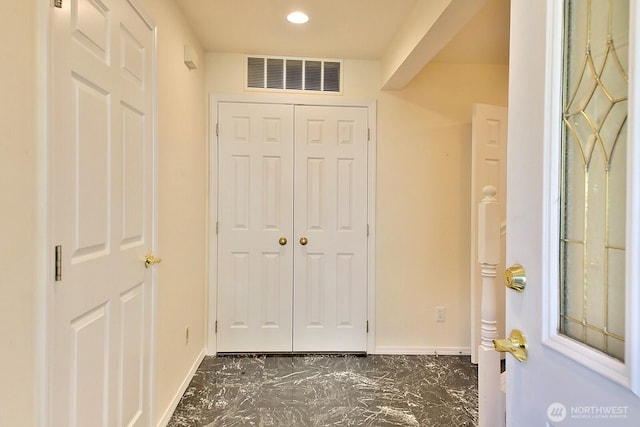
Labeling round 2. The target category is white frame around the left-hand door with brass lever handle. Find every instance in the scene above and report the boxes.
[43,0,158,427]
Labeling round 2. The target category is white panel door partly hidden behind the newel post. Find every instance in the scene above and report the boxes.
[471,104,507,363]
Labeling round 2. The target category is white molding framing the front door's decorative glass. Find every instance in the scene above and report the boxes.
[541,0,640,394]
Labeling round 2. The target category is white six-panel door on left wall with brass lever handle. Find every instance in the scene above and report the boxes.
[49,0,154,427]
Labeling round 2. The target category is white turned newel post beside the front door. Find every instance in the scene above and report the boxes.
[478,185,505,427]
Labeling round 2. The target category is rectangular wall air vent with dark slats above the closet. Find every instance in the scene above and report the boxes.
[246,55,342,94]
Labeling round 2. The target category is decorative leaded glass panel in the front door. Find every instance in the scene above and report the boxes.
[559,0,629,361]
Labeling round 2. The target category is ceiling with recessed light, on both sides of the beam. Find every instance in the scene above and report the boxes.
[177,0,510,64]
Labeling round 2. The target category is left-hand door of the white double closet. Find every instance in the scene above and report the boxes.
[217,103,294,352]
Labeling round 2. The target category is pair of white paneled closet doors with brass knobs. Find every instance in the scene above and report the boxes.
[217,102,368,352]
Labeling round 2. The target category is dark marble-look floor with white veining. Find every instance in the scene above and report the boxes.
[169,355,478,427]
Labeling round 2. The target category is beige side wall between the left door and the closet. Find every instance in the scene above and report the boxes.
[143,0,207,422]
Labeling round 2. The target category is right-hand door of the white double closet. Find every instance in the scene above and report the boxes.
[293,106,368,352]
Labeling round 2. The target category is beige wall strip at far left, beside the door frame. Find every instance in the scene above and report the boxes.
[0,0,44,426]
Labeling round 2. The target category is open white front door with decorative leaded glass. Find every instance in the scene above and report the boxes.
[506,0,640,427]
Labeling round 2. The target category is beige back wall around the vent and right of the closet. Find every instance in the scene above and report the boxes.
[206,53,508,353]
